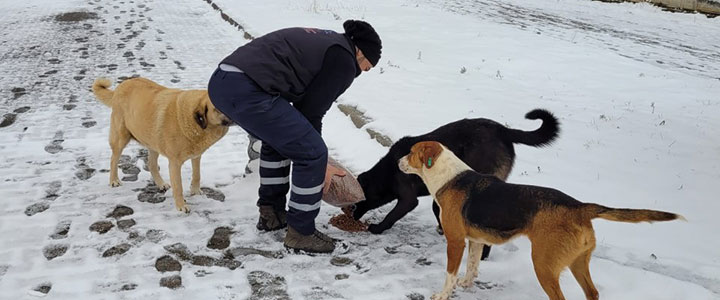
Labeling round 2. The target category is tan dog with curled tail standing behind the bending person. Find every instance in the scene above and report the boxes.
[92,78,232,213]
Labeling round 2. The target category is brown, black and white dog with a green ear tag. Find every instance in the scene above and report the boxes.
[398,142,684,300]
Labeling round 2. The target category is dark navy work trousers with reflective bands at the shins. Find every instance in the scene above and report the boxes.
[208,69,328,235]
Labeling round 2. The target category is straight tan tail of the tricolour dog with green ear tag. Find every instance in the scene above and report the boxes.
[584,203,687,223]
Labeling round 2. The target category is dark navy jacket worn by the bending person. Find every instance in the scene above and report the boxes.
[222,28,361,132]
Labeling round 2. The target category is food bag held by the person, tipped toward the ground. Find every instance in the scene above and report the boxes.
[322,158,365,207]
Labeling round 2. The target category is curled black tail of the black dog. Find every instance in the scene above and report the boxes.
[508,109,560,147]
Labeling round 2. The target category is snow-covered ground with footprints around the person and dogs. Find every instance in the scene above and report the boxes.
[0,0,720,300]
